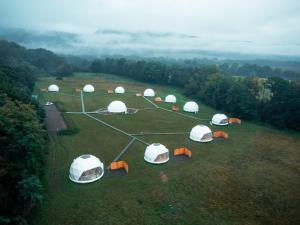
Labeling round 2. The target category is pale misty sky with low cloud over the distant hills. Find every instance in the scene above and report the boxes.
[0,0,300,55]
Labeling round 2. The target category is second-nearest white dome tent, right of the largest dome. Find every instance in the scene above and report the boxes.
[144,143,169,164]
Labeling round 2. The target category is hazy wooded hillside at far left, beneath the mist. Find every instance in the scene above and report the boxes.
[0,40,67,74]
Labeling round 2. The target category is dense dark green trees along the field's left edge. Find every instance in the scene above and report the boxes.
[0,66,47,222]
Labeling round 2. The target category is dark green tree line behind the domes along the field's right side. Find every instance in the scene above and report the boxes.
[90,58,300,131]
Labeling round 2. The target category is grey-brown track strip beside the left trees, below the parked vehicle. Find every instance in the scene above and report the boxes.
[44,105,67,134]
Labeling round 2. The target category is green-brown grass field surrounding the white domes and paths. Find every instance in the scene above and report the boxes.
[30,74,300,225]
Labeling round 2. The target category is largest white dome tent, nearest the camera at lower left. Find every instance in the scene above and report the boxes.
[69,155,104,183]
